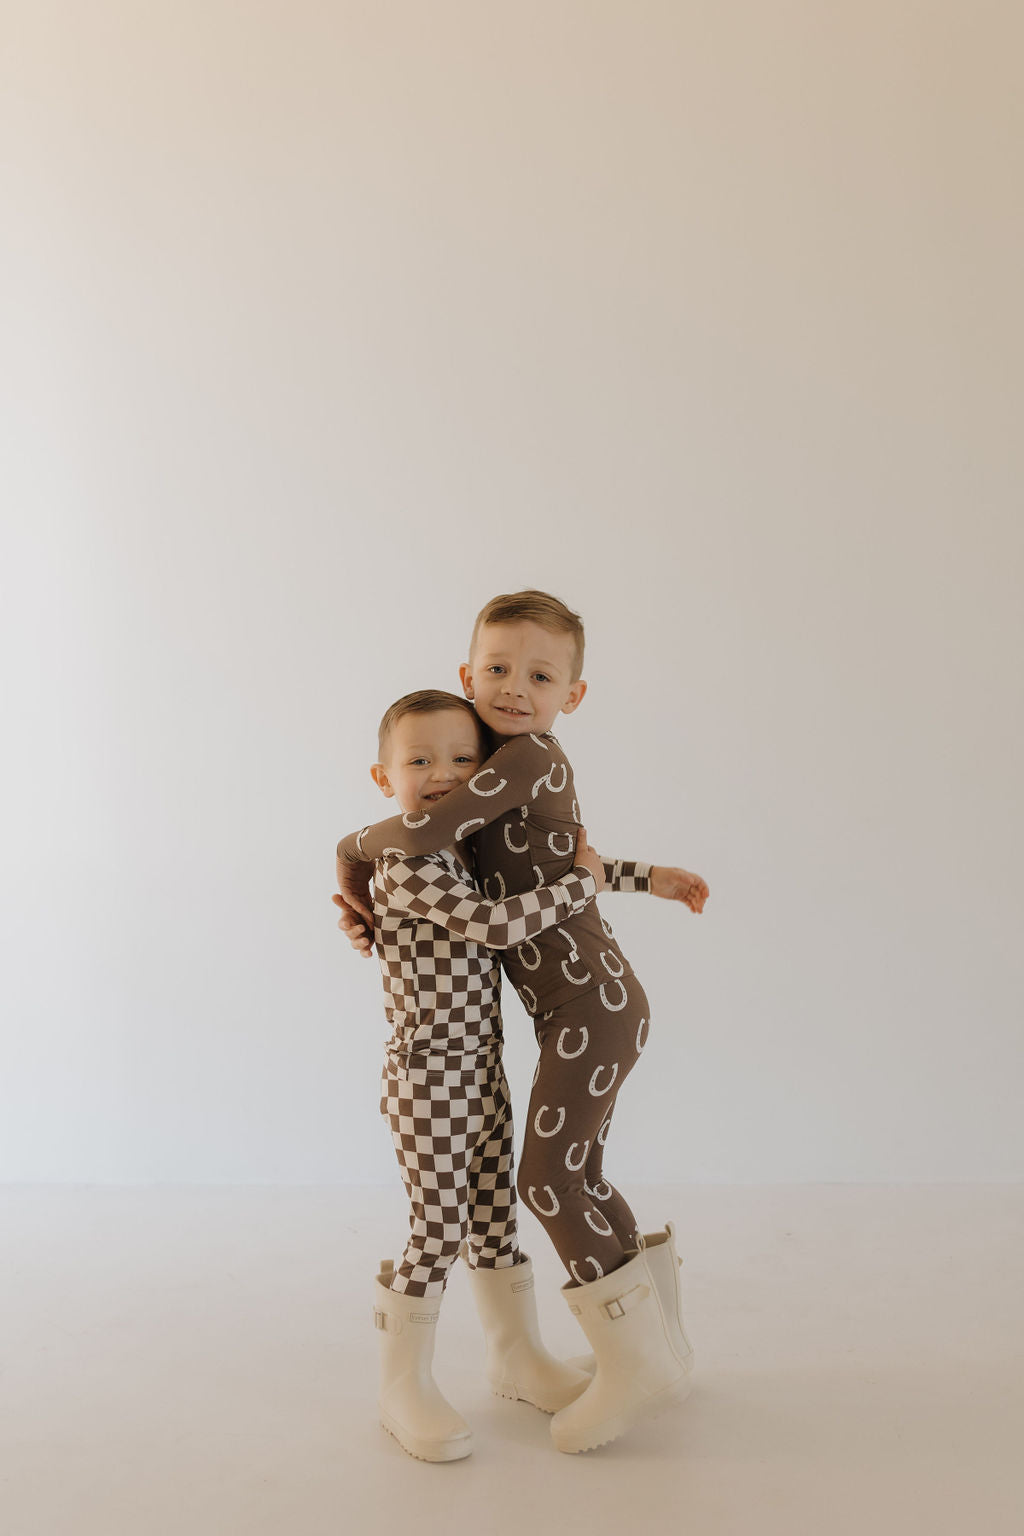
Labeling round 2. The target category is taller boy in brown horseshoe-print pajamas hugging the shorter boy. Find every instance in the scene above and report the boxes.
[338,591,708,1452]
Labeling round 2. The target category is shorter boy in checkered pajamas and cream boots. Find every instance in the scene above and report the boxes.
[360,691,603,1461]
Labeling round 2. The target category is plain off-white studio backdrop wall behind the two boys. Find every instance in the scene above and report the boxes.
[0,0,1024,1181]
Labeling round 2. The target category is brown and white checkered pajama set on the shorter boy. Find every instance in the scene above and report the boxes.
[373,851,596,1296]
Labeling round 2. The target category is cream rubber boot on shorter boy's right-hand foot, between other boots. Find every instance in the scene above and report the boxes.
[462,1249,590,1413]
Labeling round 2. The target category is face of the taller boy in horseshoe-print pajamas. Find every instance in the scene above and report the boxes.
[459,619,586,736]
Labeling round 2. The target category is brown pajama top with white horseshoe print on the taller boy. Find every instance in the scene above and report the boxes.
[338,733,651,1014]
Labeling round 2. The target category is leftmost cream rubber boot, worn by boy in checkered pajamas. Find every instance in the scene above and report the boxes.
[373,1260,473,1461]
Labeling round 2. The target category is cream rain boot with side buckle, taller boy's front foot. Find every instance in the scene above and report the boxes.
[551,1249,689,1452]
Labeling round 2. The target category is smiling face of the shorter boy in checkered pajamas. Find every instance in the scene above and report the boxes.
[370,710,484,816]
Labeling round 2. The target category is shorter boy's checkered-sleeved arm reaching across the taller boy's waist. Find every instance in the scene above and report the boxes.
[382,857,599,949]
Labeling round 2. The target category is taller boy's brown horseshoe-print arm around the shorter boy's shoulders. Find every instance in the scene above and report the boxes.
[338,736,554,878]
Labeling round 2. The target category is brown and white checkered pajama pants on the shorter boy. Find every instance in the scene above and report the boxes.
[381,1063,519,1296]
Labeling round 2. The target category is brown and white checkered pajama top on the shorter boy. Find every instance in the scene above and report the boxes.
[373,849,597,1081]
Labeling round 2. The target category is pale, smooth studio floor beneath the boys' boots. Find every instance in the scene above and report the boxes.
[0,1186,1024,1536]
